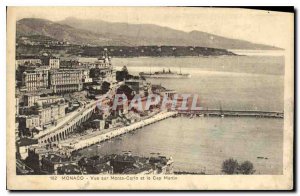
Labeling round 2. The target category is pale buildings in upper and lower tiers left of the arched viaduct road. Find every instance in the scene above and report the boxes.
[16,53,116,136]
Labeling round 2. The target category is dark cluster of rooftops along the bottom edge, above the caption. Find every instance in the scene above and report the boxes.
[19,149,173,175]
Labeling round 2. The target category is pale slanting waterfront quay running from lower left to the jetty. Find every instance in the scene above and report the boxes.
[59,111,177,153]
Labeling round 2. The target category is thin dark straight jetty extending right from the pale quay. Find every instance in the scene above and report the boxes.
[178,110,284,118]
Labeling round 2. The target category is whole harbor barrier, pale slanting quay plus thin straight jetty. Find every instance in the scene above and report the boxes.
[58,110,283,154]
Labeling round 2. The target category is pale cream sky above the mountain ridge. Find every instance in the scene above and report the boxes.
[9,7,293,48]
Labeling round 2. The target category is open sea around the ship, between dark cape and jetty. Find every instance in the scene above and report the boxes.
[113,56,284,111]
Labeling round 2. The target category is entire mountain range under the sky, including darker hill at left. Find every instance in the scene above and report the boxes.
[17,18,278,49]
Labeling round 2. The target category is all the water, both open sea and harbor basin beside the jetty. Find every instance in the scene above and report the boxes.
[78,56,284,174]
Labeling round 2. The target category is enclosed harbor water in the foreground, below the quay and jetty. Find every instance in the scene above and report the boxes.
[81,117,283,174]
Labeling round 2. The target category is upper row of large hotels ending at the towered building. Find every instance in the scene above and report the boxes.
[16,54,116,93]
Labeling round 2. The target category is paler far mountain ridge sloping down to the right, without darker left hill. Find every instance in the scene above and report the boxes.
[59,17,278,49]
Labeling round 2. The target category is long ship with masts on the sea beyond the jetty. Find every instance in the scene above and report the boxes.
[139,68,191,79]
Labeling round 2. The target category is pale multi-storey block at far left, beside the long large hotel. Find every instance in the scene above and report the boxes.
[22,67,49,92]
